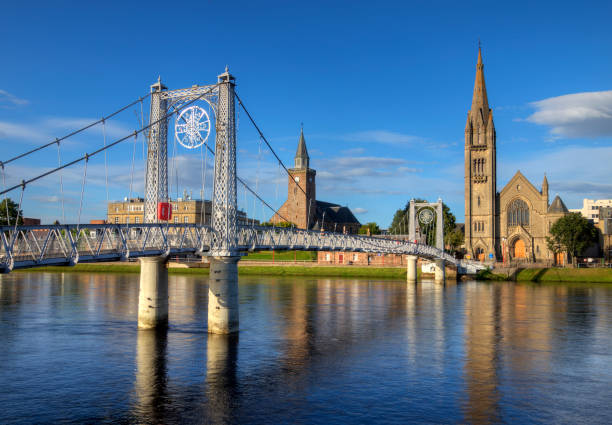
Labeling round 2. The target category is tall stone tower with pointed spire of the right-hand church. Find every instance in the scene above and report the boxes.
[465,48,498,260]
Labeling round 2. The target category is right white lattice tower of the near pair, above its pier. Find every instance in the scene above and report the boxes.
[211,68,237,257]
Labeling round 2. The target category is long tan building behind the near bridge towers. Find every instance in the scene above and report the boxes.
[106,192,253,225]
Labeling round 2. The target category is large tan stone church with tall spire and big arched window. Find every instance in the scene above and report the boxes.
[465,49,569,261]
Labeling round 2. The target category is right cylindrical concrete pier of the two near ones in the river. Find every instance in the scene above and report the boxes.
[208,256,240,334]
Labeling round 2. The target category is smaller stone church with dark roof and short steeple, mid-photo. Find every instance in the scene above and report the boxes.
[270,129,361,233]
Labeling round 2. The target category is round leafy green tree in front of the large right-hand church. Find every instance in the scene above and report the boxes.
[546,213,597,266]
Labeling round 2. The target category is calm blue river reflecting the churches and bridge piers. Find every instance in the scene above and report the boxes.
[0,273,612,424]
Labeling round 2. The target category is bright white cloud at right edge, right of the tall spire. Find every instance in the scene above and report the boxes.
[527,90,612,138]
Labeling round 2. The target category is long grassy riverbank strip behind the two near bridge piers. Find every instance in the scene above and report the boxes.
[15,264,406,279]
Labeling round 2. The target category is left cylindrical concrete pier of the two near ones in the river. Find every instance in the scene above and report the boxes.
[138,257,168,329]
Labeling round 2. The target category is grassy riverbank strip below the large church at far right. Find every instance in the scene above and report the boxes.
[476,267,612,283]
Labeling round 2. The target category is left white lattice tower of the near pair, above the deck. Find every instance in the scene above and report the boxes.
[144,79,168,223]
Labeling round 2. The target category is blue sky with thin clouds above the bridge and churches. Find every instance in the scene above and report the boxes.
[0,1,612,227]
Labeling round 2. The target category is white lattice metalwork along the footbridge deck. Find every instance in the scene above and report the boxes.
[0,223,486,273]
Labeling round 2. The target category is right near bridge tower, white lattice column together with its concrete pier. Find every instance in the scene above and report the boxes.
[208,68,240,334]
